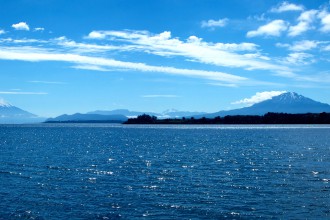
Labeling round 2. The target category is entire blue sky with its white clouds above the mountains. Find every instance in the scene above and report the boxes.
[0,0,330,117]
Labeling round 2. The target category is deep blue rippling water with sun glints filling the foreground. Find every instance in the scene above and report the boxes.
[0,125,330,219]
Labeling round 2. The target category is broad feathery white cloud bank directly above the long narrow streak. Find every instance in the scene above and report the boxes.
[87,31,287,71]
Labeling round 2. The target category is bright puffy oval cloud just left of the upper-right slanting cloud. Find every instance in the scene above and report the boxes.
[246,20,287,37]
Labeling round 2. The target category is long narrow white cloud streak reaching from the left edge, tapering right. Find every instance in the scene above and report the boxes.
[0,47,247,83]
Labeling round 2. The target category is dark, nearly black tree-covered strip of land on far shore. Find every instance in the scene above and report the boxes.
[124,112,330,124]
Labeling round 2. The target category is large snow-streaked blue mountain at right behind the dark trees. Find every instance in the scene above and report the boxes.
[195,92,330,118]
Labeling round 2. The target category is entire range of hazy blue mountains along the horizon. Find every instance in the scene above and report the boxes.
[0,92,330,123]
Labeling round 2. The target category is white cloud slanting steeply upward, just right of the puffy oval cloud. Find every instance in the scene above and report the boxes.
[288,10,318,37]
